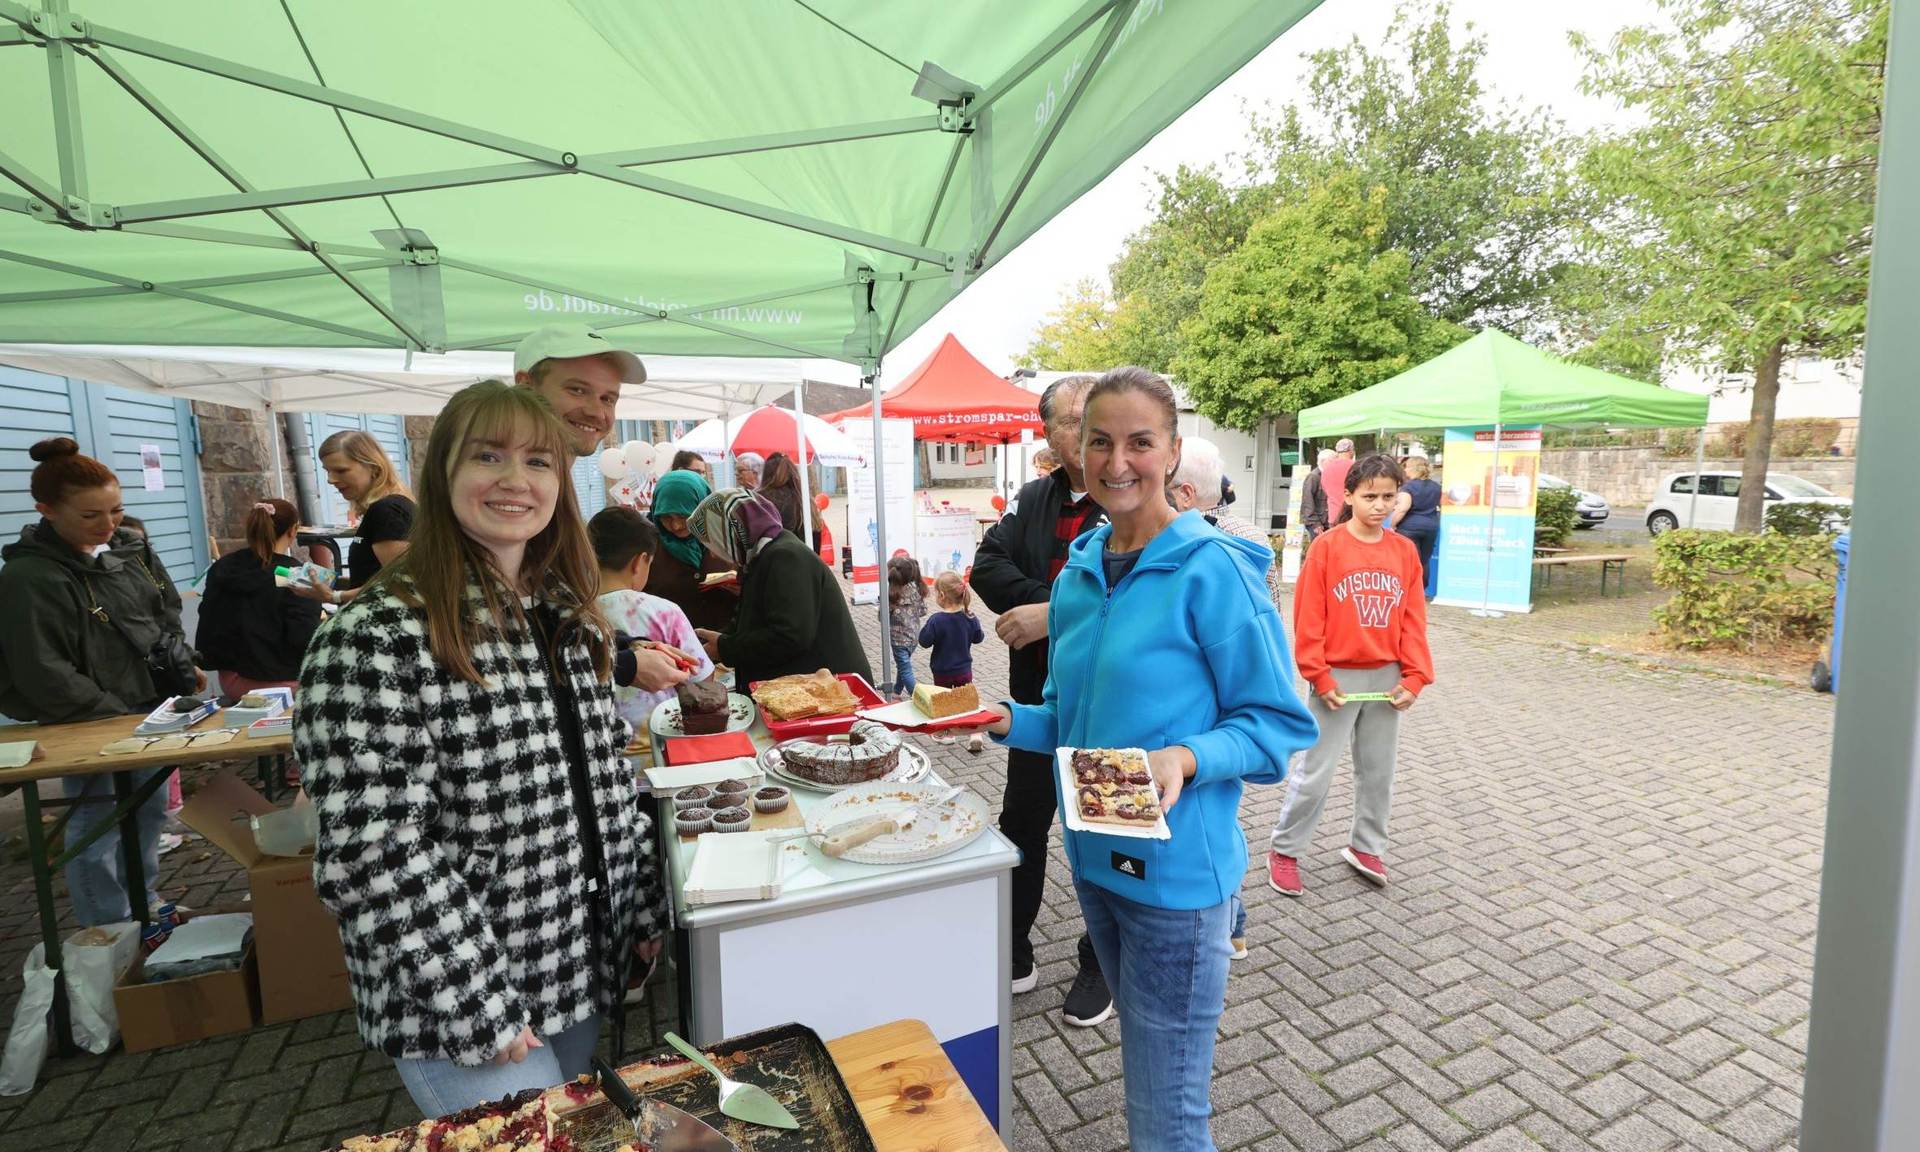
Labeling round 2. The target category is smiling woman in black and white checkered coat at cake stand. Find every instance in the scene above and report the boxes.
[294,380,664,1116]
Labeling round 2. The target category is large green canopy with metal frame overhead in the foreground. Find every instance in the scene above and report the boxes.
[0,0,1317,737]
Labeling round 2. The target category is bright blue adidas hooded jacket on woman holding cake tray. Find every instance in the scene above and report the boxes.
[1002,513,1319,908]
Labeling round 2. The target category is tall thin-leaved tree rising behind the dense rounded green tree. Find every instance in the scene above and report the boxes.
[1254,0,1584,338]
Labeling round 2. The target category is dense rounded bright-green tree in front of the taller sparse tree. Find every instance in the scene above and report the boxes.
[1173,173,1465,430]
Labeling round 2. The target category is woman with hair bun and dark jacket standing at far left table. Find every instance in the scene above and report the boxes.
[0,436,207,925]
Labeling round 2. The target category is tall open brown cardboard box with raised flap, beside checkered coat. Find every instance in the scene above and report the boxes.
[180,774,353,1023]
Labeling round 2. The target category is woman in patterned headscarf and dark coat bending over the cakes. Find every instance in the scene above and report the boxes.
[689,488,874,684]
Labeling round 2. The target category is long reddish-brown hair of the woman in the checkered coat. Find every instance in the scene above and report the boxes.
[372,380,609,684]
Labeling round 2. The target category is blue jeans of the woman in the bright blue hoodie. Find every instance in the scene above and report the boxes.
[1073,883,1233,1152]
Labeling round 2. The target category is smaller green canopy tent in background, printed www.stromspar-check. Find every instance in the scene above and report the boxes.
[1300,328,1707,616]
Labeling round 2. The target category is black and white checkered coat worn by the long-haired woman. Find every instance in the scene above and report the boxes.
[294,586,664,1064]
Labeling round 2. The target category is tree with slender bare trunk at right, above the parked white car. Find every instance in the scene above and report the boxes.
[1576,0,1887,532]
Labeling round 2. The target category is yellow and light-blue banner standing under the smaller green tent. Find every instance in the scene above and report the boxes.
[1434,426,1540,612]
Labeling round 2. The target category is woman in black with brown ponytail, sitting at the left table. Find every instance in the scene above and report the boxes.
[194,499,321,697]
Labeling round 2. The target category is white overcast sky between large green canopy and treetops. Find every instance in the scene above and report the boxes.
[883,0,1657,384]
